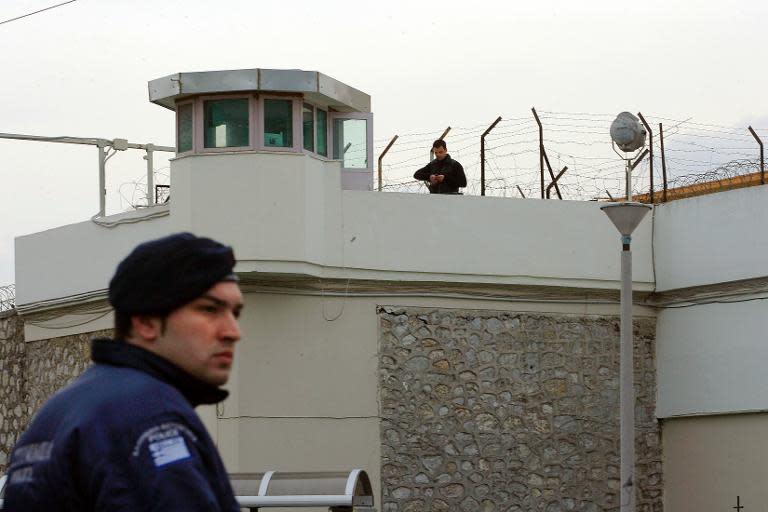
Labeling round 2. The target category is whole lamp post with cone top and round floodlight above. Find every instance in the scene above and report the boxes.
[600,112,651,512]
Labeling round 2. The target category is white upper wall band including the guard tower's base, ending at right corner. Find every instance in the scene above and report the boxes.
[16,153,654,306]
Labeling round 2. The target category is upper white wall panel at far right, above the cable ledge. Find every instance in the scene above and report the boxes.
[654,186,768,291]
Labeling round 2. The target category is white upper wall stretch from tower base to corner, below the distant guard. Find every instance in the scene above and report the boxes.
[344,191,653,290]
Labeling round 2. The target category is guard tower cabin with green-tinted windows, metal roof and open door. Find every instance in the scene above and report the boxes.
[149,69,373,190]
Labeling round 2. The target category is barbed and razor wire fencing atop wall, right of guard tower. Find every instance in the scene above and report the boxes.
[376,111,768,200]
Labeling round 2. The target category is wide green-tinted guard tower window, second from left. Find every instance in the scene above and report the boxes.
[203,98,249,148]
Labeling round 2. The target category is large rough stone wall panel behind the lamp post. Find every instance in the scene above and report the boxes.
[379,307,662,512]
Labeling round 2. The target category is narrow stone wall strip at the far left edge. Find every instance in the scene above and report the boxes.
[0,311,27,475]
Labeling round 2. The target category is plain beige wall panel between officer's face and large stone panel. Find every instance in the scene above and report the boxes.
[234,294,378,416]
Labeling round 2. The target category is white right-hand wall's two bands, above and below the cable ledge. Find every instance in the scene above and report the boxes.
[654,186,768,418]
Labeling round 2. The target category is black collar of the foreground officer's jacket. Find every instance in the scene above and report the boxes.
[91,338,229,407]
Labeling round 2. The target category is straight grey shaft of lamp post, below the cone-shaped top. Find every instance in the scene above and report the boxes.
[619,236,635,512]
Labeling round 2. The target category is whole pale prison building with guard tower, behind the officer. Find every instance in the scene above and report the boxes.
[6,70,768,512]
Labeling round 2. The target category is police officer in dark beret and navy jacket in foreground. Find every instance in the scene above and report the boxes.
[3,233,243,512]
